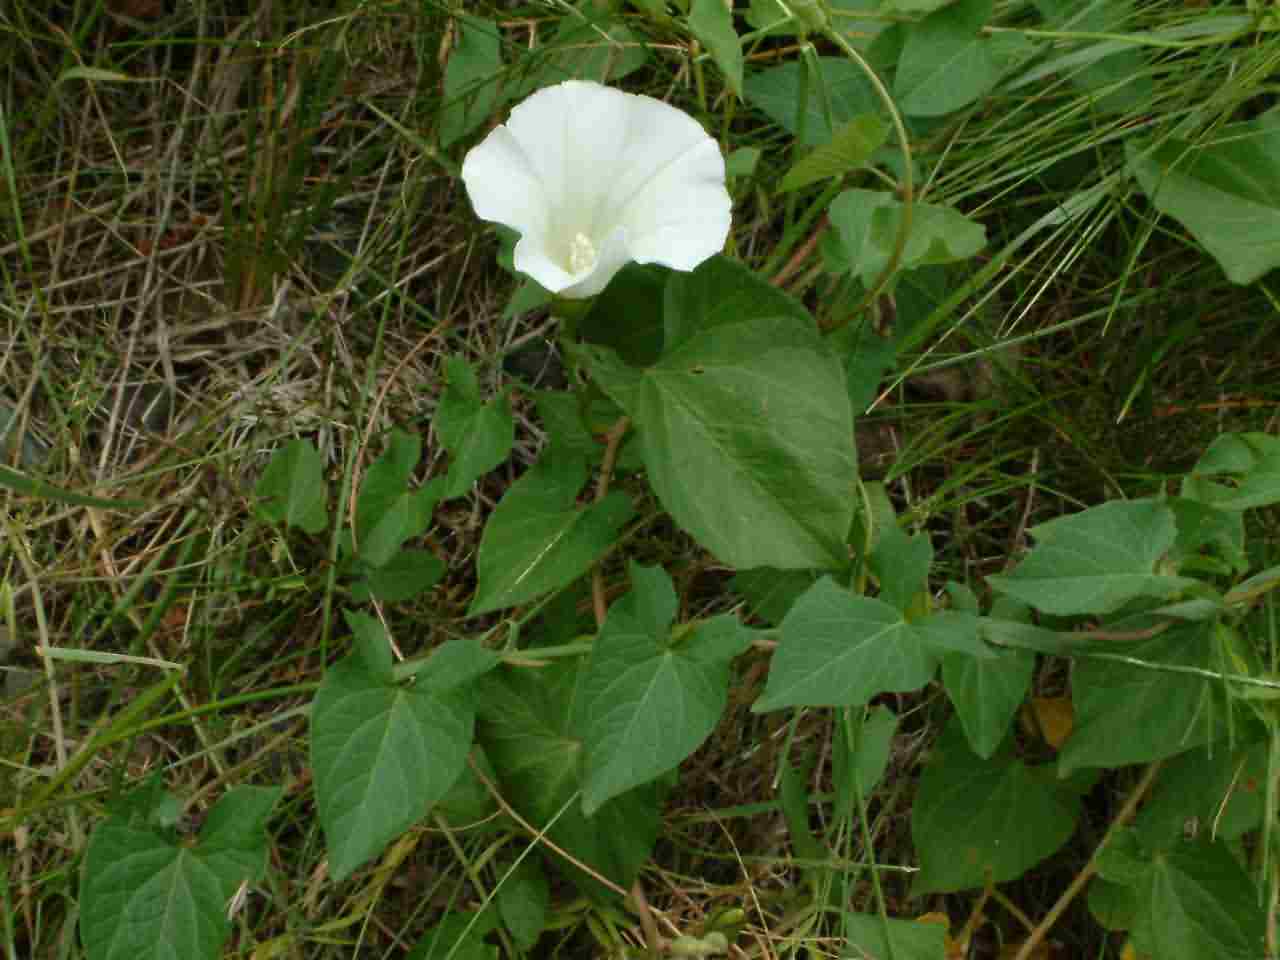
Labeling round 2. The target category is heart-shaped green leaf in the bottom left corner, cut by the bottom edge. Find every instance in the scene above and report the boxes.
[79,787,280,960]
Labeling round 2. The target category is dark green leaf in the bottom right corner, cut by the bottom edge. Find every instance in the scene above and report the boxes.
[1133,841,1266,960]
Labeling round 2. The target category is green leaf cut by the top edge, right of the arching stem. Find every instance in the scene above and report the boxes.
[893,0,1002,116]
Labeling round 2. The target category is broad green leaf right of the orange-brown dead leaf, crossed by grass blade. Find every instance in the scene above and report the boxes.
[1059,621,1226,774]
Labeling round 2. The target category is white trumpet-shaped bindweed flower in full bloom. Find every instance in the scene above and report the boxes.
[462,81,730,298]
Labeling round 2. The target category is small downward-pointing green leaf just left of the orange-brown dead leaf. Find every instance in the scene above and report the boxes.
[942,650,1036,759]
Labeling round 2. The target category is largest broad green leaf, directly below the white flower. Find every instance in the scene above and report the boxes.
[591,316,856,568]
